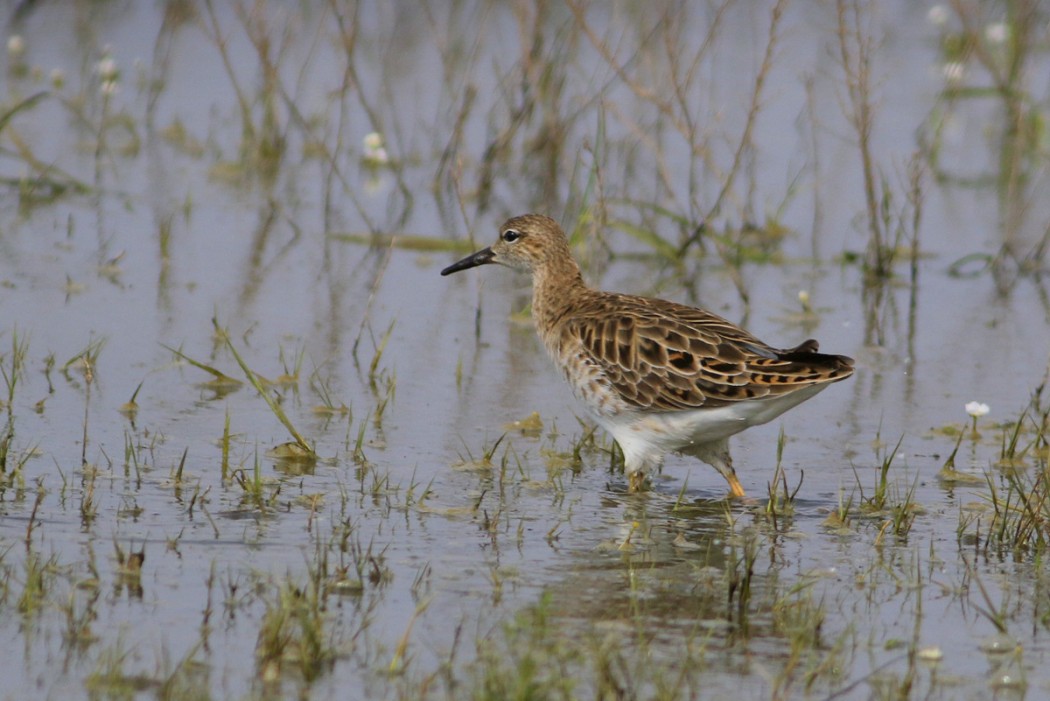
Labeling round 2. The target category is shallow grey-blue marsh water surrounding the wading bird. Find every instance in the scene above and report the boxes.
[0,2,1050,699]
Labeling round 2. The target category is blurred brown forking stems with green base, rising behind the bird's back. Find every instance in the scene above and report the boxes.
[569,2,785,303]
